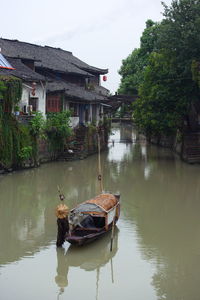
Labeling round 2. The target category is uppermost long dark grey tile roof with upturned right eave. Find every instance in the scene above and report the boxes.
[0,38,108,77]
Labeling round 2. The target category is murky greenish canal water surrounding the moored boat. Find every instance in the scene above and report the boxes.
[0,125,200,300]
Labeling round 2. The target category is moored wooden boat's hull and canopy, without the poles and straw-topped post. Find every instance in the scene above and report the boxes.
[66,193,120,245]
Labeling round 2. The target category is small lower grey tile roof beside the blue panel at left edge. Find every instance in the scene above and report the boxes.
[0,57,45,81]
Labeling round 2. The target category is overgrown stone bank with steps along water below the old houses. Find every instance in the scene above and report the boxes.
[0,122,111,174]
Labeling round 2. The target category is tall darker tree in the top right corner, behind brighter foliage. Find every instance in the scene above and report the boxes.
[157,0,200,103]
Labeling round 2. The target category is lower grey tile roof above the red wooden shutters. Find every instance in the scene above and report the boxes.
[47,80,107,102]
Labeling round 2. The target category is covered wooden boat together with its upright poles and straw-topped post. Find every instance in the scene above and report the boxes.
[56,133,120,246]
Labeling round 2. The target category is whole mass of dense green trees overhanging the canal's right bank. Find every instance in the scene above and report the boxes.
[119,0,200,135]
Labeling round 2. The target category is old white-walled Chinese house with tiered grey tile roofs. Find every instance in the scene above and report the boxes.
[0,38,109,126]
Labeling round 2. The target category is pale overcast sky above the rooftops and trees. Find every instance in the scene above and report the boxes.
[0,0,171,93]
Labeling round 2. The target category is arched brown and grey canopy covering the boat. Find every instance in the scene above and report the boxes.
[72,193,118,214]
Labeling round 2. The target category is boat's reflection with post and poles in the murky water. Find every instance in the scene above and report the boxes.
[55,226,119,296]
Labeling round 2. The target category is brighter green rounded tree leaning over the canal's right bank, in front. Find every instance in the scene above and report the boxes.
[133,52,189,136]
